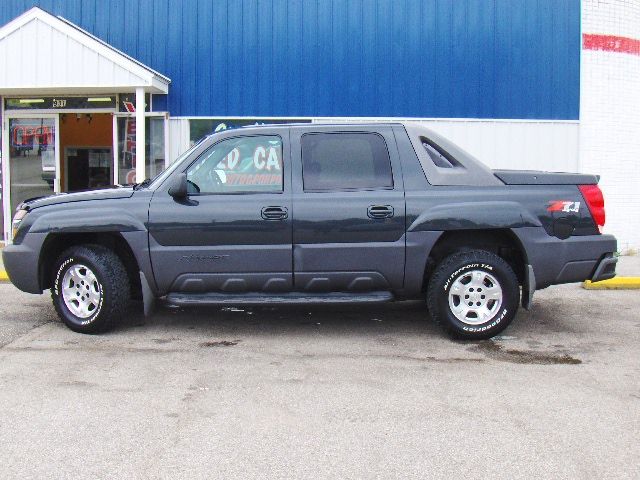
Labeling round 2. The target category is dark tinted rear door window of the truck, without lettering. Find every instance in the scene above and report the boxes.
[301,133,393,191]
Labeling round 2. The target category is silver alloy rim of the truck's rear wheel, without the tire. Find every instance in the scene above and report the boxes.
[449,270,503,325]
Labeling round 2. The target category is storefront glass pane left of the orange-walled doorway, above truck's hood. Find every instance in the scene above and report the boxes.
[4,115,59,216]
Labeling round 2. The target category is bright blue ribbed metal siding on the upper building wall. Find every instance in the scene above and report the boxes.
[0,0,580,119]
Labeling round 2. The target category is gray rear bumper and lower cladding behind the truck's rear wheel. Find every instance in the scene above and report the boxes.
[513,227,617,290]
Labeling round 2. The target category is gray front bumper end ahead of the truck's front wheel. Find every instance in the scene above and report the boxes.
[2,233,46,293]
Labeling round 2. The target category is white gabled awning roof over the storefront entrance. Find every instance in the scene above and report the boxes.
[0,7,171,95]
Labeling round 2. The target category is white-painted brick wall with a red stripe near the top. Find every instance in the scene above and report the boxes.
[579,0,640,252]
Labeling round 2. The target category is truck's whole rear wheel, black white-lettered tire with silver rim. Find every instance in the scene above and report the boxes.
[427,250,520,340]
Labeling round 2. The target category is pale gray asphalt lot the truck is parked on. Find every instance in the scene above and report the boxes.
[0,258,640,479]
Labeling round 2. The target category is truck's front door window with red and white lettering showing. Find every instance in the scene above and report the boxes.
[187,135,283,194]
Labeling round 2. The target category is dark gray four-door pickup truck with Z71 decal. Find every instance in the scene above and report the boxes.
[3,123,616,339]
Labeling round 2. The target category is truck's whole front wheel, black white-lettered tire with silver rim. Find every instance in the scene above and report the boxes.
[51,245,131,334]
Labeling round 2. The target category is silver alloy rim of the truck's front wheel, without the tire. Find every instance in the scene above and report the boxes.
[62,264,102,318]
